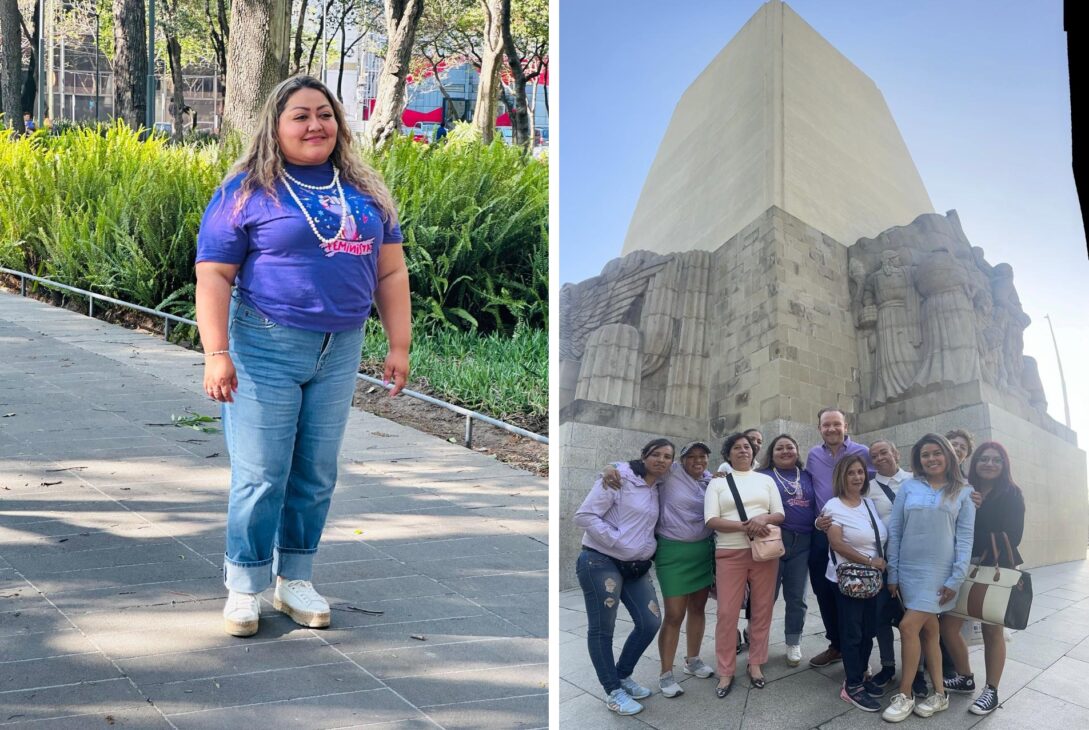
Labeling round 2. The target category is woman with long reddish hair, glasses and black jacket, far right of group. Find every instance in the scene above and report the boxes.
[942,441,1025,715]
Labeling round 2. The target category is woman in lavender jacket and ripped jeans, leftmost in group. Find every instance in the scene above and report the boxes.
[575,439,674,715]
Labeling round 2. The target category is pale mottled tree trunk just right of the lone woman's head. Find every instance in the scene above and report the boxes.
[368,0,424,149]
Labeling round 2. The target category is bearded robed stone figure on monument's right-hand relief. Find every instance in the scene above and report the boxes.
[862,248,921,404]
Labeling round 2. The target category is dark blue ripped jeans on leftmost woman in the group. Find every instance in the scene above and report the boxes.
[575,548,662,693]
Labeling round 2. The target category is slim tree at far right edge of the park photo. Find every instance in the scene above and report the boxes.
[503,0,548,147]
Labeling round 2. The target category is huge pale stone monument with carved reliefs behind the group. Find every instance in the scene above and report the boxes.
[560,2,1089,588]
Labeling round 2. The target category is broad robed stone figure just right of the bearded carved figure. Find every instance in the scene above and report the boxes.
[915,246,980,387]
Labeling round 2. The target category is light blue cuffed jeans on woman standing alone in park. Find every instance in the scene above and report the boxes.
[223,296,363,593]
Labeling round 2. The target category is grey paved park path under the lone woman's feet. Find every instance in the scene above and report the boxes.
[0,292,549,730]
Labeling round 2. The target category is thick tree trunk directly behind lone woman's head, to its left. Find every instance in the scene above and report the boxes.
[223,0,291,146]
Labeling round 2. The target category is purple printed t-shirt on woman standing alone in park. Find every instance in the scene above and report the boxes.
[196,162,402,332]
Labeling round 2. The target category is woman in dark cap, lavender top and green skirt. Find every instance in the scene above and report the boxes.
[603,441,714,697]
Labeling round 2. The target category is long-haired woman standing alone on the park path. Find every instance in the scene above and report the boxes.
[196,76,412,636]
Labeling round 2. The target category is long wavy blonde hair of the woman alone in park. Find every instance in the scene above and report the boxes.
[223,75,397,226]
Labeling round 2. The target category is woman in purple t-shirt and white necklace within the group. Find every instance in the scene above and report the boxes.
[759,434,817,667]
